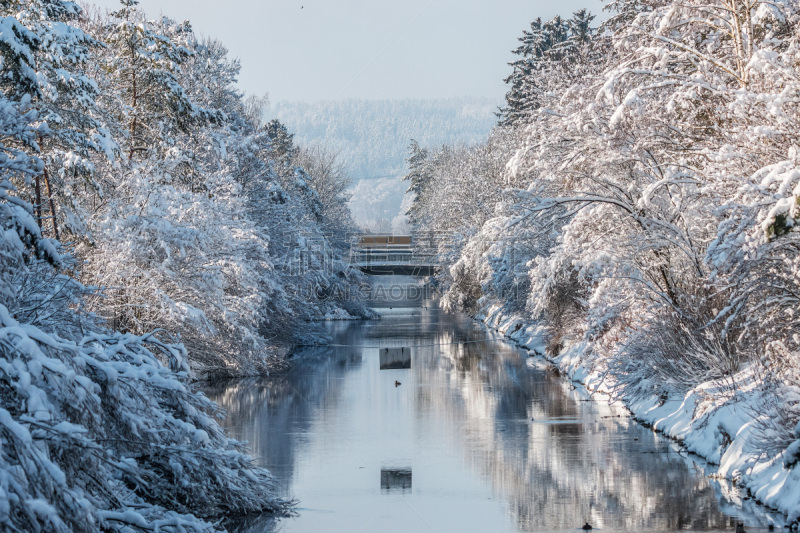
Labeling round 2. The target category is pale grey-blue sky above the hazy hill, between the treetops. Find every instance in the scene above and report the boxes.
[90,0,602,102]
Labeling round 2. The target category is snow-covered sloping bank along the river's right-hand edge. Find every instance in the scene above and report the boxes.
[474,304,800,524]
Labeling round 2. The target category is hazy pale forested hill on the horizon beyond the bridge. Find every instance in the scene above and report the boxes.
[268,98,498,181]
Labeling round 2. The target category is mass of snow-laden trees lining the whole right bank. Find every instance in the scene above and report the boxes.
[412,0,800,520]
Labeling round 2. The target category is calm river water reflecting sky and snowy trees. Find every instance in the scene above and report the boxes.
[206,278,782,532]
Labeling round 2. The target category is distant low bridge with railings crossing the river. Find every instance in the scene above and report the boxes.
[350,235,439,276]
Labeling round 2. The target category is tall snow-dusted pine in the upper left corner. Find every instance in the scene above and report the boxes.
[0,0,109,237]
